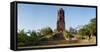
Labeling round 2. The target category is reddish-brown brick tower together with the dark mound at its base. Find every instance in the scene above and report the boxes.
[54,8,65,40]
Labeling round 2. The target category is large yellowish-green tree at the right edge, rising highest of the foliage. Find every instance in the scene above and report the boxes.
[78,18,96,39]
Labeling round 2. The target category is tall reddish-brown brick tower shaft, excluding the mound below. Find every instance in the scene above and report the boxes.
[57,8,65,32]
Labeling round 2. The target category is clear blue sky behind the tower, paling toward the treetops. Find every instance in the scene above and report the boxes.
[17,3,96,31]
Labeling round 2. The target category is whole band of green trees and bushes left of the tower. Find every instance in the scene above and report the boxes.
[18,27,53,46]
